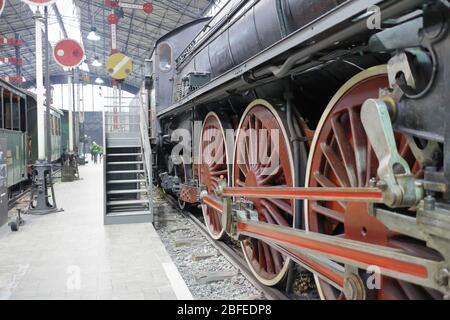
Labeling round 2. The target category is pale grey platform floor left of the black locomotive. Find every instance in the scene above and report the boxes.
[0,164,192,300]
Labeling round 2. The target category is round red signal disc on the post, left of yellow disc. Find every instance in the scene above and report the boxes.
[53,39,84,68]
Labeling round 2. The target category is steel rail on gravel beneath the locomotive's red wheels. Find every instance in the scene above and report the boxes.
[164,194,310,300]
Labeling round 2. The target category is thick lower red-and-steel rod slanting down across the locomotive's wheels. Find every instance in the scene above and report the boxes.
[236,218,448,293]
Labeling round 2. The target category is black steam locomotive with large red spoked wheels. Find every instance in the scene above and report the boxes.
[142,0,450,299]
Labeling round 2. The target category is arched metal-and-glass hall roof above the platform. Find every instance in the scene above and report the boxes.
[0,0,214,92]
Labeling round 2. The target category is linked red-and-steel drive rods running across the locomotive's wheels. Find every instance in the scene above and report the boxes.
[201,188,449,293]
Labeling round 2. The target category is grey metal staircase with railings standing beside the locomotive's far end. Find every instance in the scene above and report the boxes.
[103,90,153,224]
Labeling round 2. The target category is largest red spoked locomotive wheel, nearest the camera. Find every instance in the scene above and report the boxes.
[305,66,442,300]
